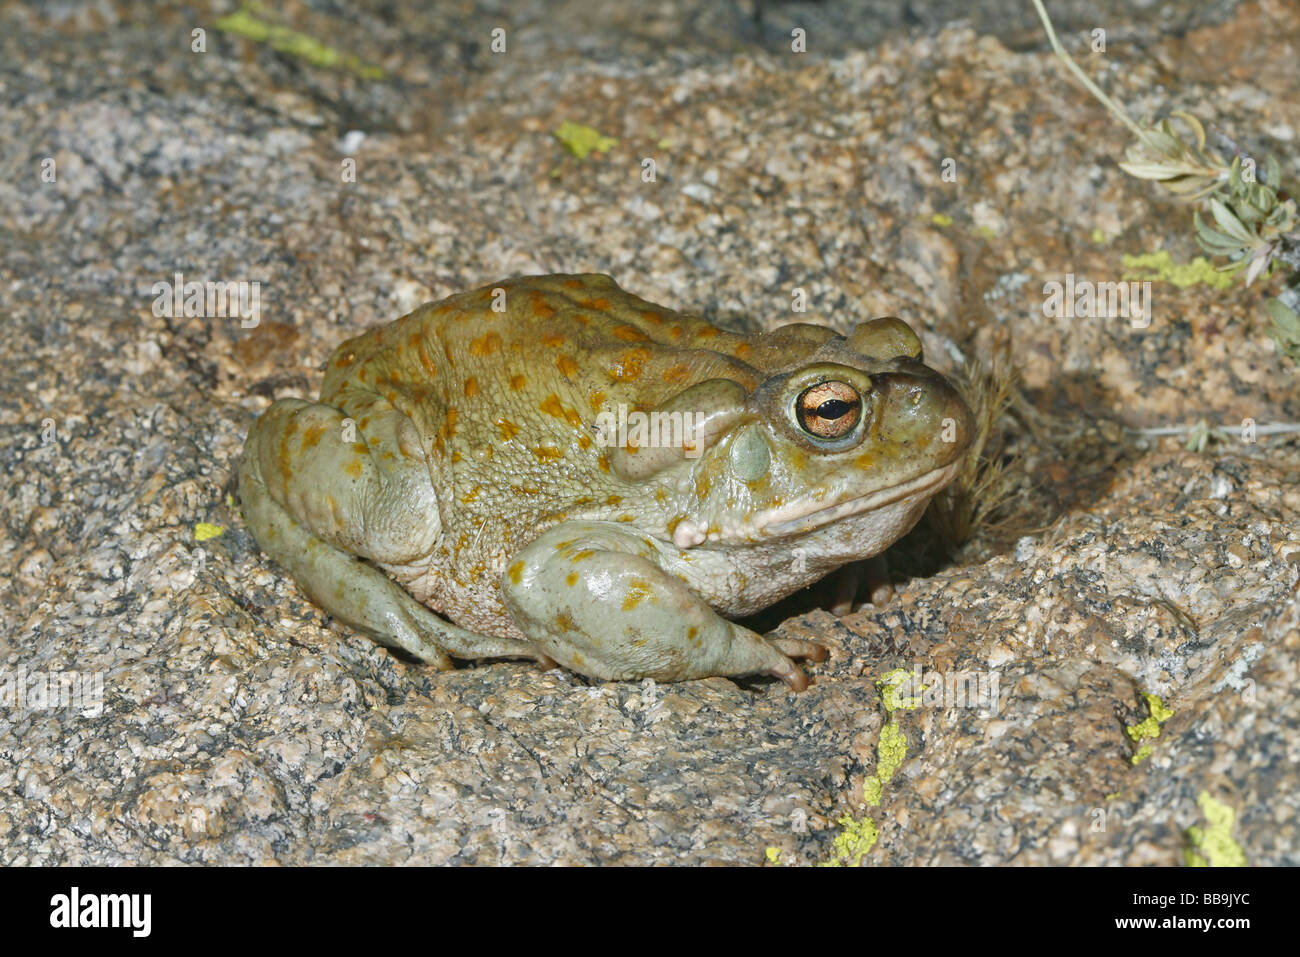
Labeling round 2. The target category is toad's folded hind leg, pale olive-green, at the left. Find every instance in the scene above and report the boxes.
[239,399,549,668]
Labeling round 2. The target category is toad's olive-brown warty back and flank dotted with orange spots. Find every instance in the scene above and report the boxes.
[321,274,763,534]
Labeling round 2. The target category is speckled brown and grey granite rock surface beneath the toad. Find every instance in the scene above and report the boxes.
[0,0,1300,865]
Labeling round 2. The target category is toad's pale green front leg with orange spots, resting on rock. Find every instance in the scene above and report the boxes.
[502,521,826,690]
